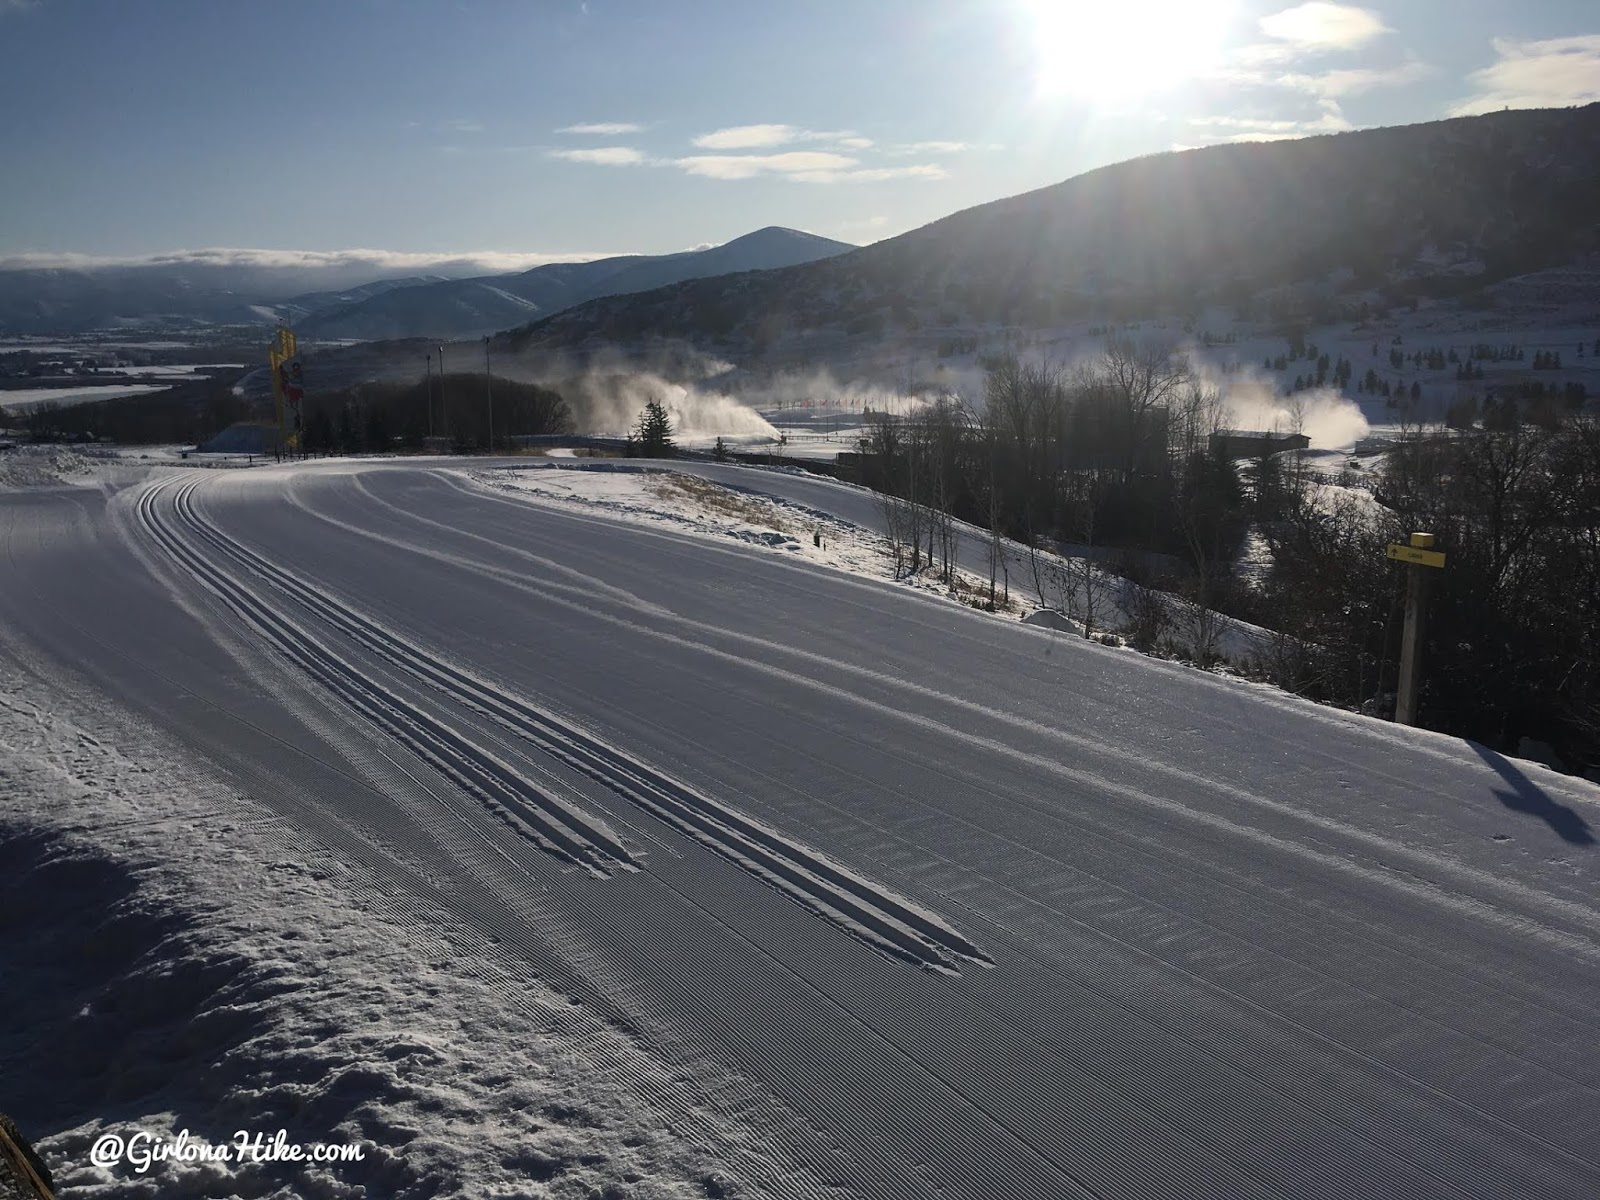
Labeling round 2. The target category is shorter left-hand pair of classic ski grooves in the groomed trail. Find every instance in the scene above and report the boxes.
[138,480,637,875]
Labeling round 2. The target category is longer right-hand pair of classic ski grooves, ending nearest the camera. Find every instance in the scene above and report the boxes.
[156,480,992,971]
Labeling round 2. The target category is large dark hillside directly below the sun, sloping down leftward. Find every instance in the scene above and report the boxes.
[504,104,1600,354]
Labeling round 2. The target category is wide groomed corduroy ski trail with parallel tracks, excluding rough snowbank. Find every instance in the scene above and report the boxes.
[0,462,1600,1200]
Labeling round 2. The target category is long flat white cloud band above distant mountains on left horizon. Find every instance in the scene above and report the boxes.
[0,246,614,274]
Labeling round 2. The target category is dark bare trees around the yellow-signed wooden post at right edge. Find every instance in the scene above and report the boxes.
[1253,412,1600,766]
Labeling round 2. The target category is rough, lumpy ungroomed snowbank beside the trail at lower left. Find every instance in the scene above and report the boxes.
[0,662,744,1200]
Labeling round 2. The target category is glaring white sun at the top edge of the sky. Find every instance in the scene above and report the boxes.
[1027,0,1235,101]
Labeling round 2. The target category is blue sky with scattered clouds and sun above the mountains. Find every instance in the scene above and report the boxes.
[0,0,1600,269]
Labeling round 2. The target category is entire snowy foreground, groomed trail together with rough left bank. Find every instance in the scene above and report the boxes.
[0,459,1600,1200]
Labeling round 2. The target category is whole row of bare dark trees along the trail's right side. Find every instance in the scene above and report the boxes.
[858,341,1600,765]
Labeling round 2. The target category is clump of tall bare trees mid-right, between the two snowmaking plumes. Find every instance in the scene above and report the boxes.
[859,339,1248,611]
